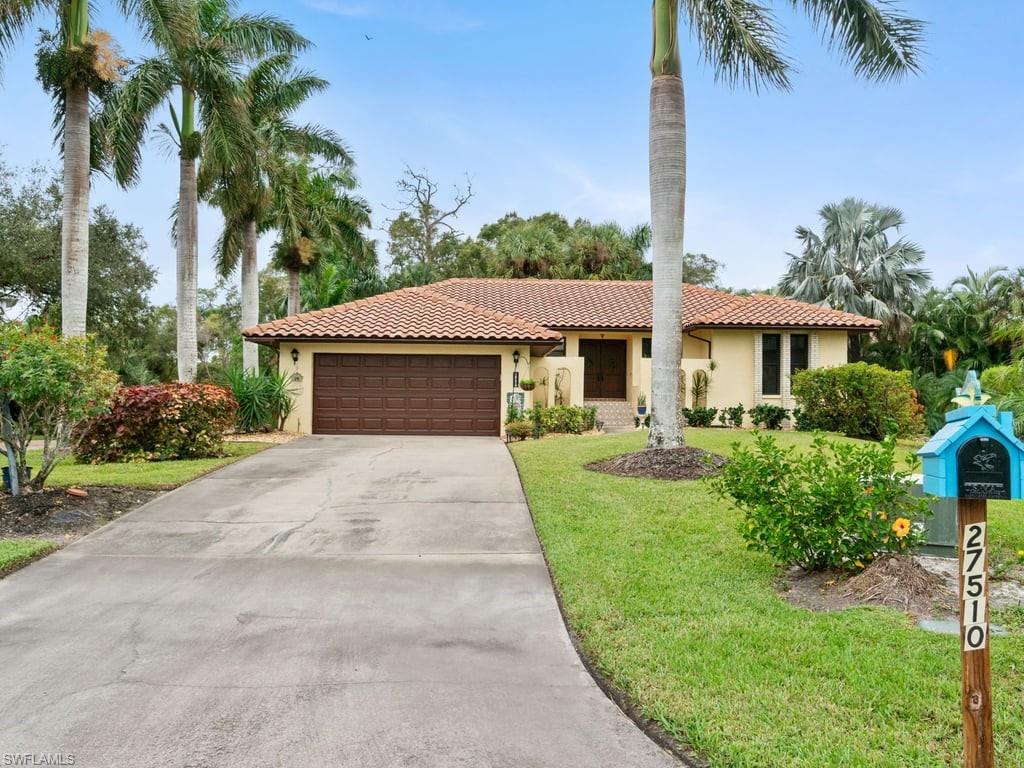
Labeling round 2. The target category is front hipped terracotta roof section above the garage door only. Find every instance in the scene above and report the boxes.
[242,287,562,342]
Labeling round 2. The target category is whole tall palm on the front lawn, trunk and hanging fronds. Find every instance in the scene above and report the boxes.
[648,0,923,447]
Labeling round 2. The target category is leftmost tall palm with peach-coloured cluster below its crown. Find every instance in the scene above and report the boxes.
[0,0,133,336]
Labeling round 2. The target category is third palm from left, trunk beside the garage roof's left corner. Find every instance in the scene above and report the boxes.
[199,54,352,371]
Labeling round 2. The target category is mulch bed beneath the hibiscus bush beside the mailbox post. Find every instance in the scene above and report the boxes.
[783,555,957,617]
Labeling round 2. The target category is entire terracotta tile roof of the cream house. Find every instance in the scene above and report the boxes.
[243,278,881,342]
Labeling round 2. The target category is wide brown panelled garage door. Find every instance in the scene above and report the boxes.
[313,354,501,435]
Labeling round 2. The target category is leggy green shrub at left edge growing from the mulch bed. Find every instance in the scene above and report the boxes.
[0,323,117,488]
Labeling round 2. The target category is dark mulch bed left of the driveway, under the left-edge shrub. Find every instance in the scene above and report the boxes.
[0,487,161,543]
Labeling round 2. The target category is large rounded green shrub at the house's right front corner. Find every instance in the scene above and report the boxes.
[793,362,925,440]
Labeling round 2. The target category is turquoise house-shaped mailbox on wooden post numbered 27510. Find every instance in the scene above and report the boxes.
[918,371,1024,768]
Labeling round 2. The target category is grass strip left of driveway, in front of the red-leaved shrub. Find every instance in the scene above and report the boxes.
[0,442,270,488]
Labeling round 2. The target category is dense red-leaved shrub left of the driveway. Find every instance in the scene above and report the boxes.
[76,384,238,463]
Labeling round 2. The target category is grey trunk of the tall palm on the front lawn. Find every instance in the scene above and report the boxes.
[647,0,686,447]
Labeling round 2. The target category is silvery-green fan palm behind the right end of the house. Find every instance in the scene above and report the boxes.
[779,198,932,352]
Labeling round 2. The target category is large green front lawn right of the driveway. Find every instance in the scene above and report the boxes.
[512,429,1024,768]
